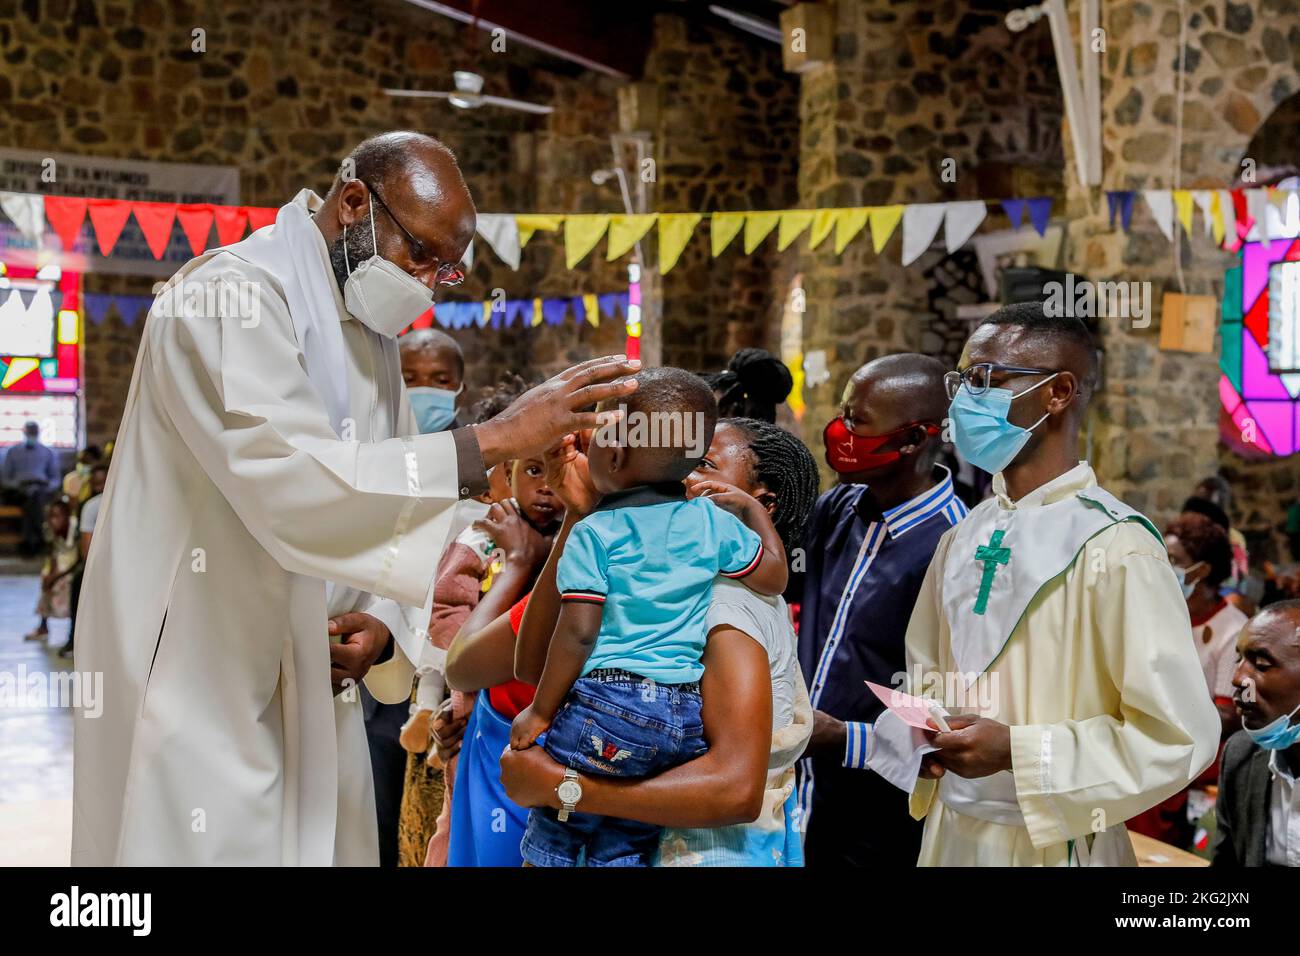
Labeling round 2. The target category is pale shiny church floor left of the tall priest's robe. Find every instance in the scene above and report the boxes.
[0,562,73,866]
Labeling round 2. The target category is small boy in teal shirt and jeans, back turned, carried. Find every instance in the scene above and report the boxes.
[511,368,787,866]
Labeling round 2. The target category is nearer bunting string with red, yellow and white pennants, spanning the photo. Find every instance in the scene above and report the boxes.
[0,186,1295,273]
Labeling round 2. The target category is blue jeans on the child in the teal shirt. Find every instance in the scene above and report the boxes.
[520,675,709,866]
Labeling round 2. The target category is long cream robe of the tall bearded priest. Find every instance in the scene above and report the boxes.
[73,191,481,865]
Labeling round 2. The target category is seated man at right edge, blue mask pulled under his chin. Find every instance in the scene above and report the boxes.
[1212,601,1300,866]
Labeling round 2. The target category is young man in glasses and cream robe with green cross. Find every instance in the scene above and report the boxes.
[868,304,1218,866]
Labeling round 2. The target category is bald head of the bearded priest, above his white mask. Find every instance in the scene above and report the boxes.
[316,131,477,290]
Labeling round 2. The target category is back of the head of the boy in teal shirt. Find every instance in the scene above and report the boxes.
[611,367,718,481]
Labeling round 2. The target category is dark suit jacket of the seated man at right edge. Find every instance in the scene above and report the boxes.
[1212,730,1273,866]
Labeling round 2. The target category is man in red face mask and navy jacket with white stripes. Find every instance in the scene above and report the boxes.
[798,354,966,866]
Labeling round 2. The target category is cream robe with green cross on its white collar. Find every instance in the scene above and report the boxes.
[868,462,1219,866]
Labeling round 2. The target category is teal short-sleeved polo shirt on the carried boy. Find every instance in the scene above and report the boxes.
[555,483,763,684]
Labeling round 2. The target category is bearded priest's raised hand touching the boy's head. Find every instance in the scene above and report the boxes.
[473,355,641,468]
